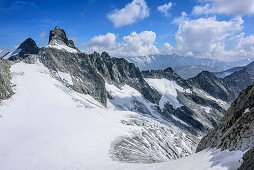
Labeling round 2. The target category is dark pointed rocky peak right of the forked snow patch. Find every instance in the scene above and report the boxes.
[188,71,237,101]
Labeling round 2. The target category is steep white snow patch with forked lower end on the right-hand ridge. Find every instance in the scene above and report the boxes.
[145,78,191,110]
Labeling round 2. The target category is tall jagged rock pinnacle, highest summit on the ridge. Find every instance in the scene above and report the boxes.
[49,26,77,49]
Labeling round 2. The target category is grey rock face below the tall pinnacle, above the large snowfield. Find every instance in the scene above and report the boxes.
[39,48,107,105]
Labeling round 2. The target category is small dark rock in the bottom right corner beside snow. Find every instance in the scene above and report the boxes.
[238,148,254,170]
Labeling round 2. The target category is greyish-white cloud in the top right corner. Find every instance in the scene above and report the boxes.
[192,0,254,15]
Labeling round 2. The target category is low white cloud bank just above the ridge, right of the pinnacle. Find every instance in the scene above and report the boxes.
[84,31,159,56]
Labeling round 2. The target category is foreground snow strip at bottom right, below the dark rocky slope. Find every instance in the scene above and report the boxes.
[131,149,244,170]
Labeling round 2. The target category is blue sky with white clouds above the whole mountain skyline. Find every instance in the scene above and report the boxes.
[0,0,254,60]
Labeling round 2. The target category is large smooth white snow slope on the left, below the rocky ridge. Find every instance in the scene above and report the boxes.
[0,60,137,170]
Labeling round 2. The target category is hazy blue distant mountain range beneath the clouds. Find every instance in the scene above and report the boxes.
[124,54,253,79]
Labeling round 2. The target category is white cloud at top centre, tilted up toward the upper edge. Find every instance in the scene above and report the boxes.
[107,0,149,27]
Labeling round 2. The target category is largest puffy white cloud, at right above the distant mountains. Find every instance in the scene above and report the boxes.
[175,17,243,60]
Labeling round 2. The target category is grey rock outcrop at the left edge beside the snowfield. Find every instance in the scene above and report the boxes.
[0,58,14,101]
